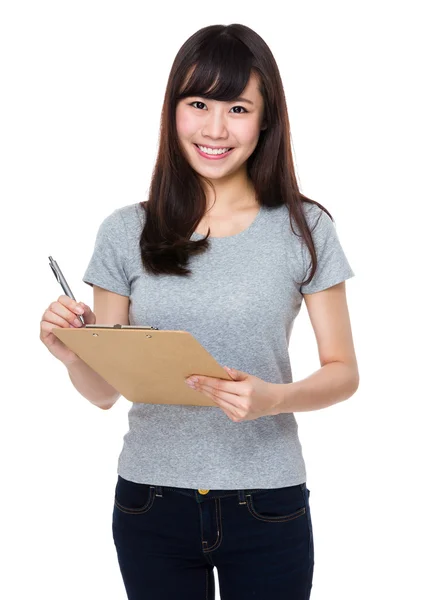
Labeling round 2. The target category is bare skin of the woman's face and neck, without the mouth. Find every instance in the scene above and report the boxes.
[176,74,265,219]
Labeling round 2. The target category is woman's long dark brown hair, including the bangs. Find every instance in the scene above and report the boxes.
[140,24,333,284]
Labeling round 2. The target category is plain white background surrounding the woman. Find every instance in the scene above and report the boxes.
[0,0,422,600]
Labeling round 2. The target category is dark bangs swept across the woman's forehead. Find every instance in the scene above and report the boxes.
[177,36,253,102]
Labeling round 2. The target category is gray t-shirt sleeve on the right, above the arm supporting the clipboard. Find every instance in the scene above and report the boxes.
[300,205,355,294]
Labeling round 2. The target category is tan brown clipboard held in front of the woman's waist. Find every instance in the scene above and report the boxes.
[52,324,232,407]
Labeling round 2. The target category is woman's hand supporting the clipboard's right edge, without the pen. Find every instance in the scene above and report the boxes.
[185,367,282,422]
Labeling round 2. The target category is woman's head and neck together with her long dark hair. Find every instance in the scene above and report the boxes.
[140,24,329,292]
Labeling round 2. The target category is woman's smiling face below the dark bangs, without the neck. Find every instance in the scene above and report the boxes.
[176,74,264,179]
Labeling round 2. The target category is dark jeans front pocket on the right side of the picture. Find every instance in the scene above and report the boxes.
[246,485,306,522]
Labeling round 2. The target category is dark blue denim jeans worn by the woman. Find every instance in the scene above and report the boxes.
[112,476,314,600]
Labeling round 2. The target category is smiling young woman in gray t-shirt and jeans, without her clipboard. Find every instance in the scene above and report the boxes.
[40,24,359,600]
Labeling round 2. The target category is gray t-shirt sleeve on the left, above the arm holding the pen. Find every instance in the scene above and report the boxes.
[82,209,130,296]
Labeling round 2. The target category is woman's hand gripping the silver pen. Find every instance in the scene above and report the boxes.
[40,294,97,366]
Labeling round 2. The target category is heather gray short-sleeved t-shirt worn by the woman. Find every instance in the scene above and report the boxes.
[83,203,354,490]
